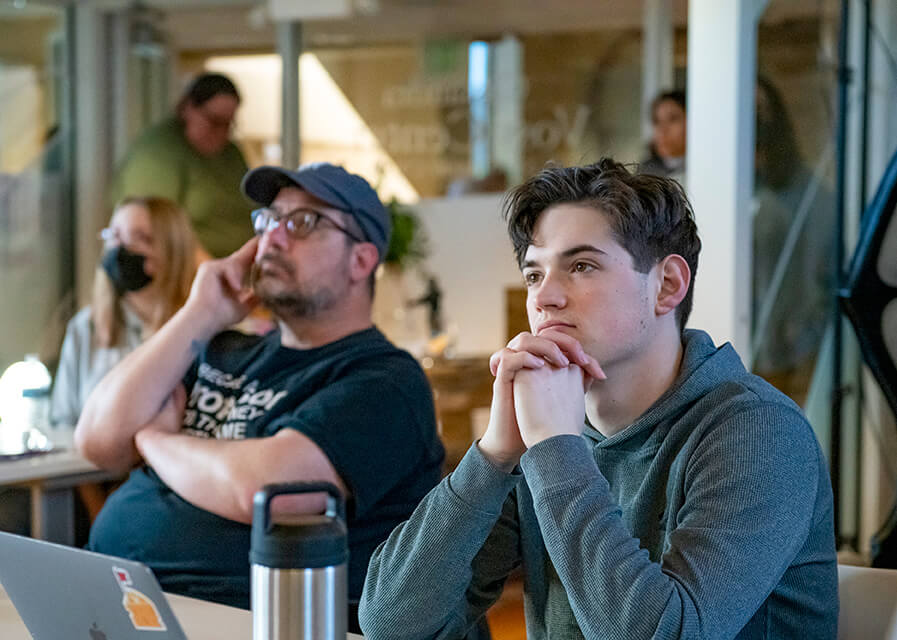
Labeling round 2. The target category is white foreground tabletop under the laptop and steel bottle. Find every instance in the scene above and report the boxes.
[0,587,364,640]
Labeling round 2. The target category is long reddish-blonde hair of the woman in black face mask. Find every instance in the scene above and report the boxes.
[91,196,198,347]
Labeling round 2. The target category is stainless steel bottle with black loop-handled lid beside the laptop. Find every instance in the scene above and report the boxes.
[249,482,349,640]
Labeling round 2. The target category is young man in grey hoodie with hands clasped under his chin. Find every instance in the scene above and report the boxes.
[361,159,838,640]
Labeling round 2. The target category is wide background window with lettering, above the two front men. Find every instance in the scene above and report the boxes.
[194,25,685,201]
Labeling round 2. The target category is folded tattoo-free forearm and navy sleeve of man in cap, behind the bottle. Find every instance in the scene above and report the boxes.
[135,356,435,523]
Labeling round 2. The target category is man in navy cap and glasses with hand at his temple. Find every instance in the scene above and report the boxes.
[75,163,444,627]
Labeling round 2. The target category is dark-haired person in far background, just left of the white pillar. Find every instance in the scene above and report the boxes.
[639,89,686,183]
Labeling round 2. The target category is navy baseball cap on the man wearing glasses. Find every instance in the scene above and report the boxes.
[240,162,392,262]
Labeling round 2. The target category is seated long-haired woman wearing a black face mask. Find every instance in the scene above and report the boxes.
[50,197,196,521]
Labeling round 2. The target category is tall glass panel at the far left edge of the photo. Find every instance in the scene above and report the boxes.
[0,3,74,371]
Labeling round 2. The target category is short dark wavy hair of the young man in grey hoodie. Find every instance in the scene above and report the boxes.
[504,158,701,331]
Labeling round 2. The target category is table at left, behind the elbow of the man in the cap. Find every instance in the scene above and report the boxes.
[0,427,118,545]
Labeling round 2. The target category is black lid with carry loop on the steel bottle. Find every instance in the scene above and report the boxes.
[249,483,349,569]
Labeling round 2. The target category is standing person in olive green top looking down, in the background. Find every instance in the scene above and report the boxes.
[110,73,252,258]
